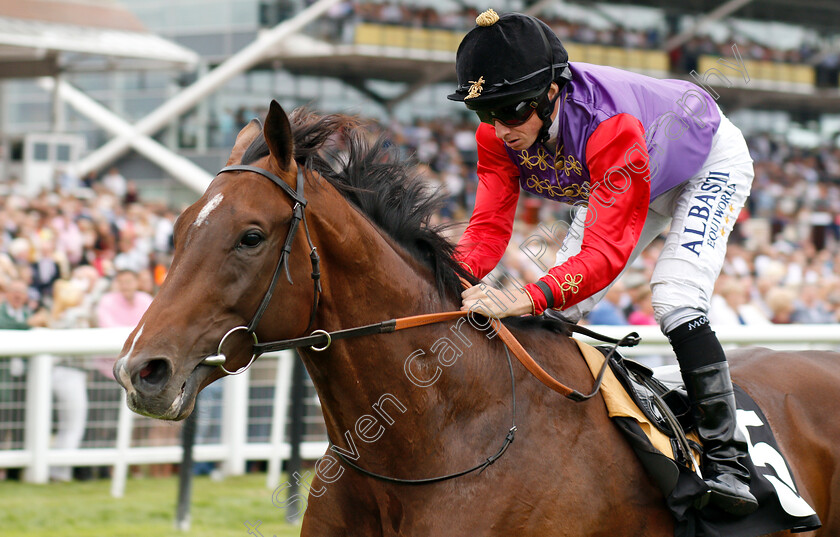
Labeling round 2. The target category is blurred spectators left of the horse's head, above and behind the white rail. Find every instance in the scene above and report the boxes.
[0,169,175,481]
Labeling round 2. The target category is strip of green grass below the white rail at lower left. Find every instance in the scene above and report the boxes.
[0,474,300,537]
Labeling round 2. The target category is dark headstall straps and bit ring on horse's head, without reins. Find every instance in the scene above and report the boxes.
[202,164,322,375]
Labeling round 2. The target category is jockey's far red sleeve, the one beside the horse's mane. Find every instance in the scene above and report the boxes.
[454,123,519,279]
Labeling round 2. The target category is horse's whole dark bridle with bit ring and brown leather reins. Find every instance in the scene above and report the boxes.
[202,164,639,485]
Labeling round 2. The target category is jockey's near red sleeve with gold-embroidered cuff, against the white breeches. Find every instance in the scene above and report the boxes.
[525,114,650,314]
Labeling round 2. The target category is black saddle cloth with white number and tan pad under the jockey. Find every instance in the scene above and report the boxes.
[575,340,821,537]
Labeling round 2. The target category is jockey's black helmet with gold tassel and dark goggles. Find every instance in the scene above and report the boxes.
[448,9,571,142]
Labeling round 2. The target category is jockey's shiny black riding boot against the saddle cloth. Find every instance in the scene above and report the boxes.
[668,317,758,516]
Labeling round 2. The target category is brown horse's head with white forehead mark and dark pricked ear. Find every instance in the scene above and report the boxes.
[114,102,313,420]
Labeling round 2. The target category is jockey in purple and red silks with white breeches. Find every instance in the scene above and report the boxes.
[449,10,758,510]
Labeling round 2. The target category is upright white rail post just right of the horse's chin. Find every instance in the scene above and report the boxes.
[222,369,251,475]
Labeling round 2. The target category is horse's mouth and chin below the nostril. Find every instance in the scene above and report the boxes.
[126,364,217,421]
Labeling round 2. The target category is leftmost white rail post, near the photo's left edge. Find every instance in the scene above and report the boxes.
[24,354,53,483]
